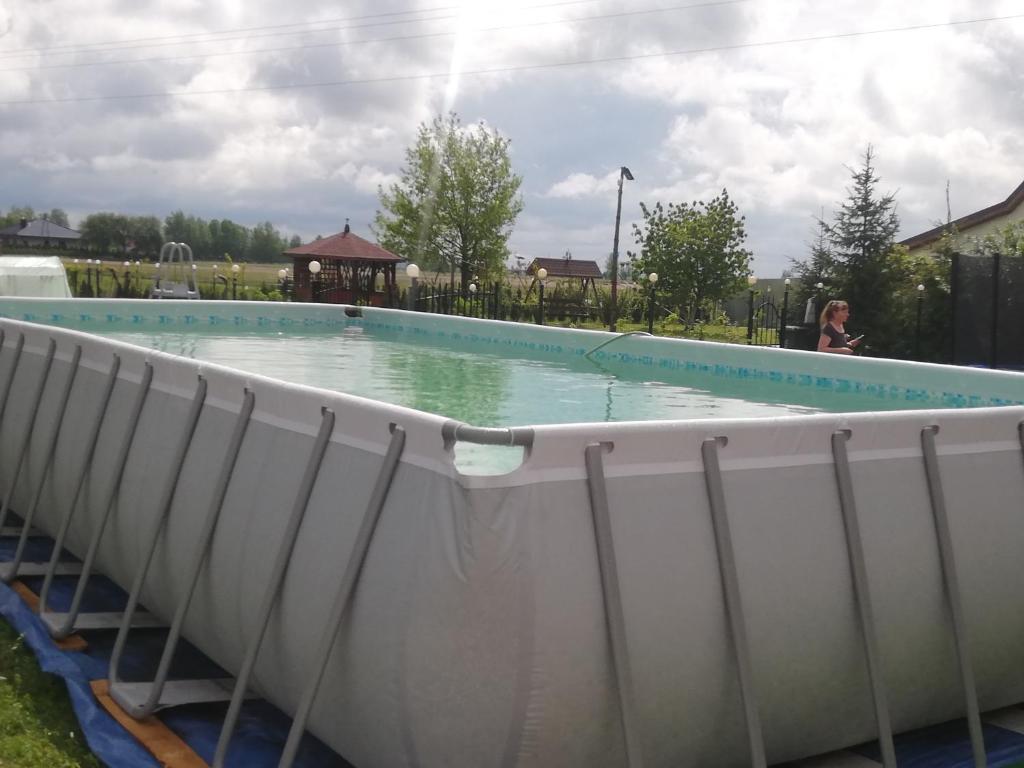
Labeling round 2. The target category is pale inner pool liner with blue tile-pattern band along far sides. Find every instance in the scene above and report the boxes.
[6,297,1024,409]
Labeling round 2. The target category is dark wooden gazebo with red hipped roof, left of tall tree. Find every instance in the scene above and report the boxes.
[285,221,401,306]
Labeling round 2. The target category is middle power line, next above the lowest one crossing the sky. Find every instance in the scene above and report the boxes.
[0,0,751,72]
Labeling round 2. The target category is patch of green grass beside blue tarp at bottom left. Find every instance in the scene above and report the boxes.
[0,618,101,768]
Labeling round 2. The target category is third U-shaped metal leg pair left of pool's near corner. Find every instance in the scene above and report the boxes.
[39,364,159,638]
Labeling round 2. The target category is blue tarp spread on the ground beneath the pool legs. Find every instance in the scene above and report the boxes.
[6,524,1024,768]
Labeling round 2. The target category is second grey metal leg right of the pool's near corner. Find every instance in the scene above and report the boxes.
[700,437,768,768]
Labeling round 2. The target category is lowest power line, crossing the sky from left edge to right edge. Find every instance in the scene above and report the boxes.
[0,13,1024,106]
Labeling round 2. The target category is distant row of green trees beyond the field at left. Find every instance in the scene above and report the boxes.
[0,206,302,263]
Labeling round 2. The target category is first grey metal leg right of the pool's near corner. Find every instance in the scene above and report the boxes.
[584,442,643,768]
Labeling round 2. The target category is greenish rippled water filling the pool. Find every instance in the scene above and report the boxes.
[102,326,929,427]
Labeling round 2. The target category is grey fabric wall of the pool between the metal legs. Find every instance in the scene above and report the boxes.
[0,301,1024,766]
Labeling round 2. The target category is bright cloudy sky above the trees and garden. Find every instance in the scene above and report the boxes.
[0,0,1024,276]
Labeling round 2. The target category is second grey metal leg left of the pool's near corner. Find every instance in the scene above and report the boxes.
[213,408,335,768]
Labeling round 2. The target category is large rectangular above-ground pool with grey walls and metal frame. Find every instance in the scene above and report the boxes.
[0,300,1024,767]
